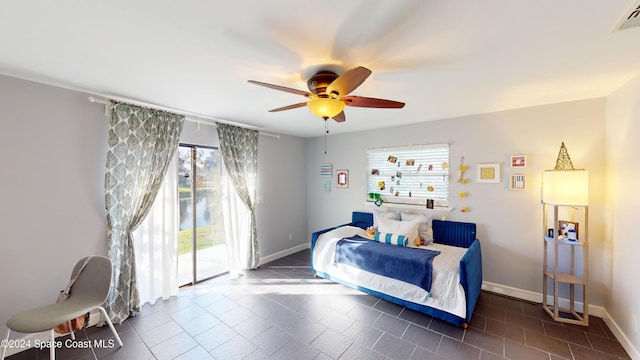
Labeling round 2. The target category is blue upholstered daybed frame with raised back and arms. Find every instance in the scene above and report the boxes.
[311,211,482,328]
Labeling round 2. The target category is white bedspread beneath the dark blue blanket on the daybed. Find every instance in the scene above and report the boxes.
[313,226,467,318]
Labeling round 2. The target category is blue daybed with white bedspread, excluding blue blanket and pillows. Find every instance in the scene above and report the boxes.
[311,211,482,328]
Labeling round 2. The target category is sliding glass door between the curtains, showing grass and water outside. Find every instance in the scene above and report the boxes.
[178,144,229,285]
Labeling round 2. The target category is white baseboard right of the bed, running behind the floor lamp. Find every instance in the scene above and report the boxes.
[482,281,640,360]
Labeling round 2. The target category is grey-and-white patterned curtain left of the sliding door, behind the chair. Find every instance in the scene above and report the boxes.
[105,101,184,322]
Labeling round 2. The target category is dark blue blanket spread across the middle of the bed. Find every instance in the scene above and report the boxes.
[335,235,440,296]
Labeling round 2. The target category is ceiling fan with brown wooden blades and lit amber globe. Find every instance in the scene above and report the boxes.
[249,66,404,122]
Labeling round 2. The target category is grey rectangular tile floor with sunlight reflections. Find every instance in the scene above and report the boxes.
[9,250,630,360]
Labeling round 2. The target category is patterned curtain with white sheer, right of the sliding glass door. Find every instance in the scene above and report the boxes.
[217,124,260,277]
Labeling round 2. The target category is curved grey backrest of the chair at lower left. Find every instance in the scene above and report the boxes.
[70,256,112,304]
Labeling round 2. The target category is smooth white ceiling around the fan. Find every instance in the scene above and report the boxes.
[0,0,640,137]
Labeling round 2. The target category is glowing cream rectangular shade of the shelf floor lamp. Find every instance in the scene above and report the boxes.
[542,170,589,205]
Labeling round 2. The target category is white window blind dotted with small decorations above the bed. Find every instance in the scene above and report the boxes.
[367,144,449,206]
